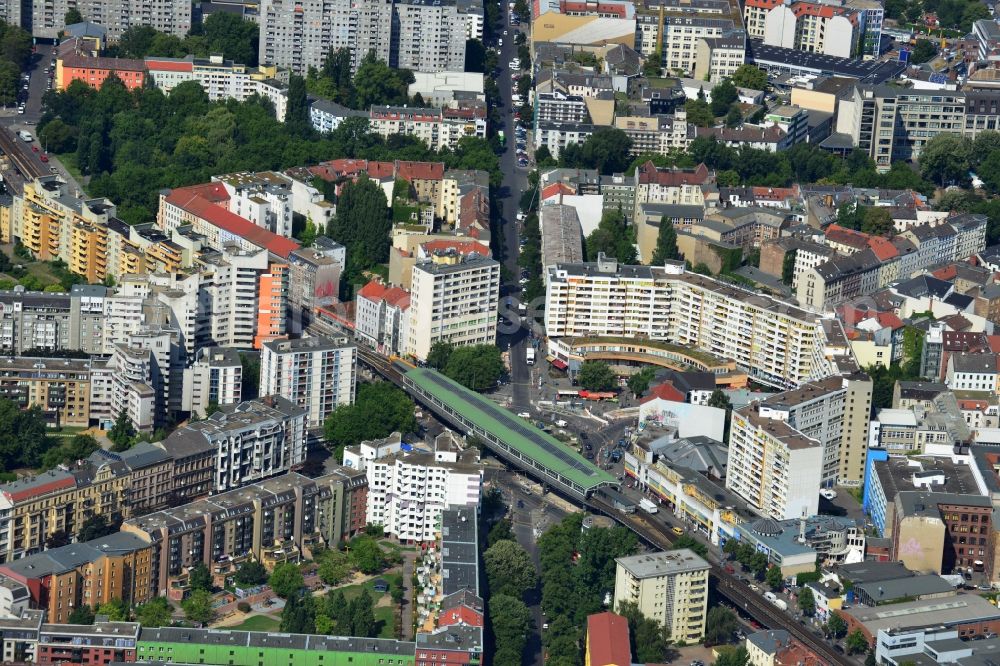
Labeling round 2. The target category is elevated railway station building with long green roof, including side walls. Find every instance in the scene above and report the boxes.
[397,366,618,499]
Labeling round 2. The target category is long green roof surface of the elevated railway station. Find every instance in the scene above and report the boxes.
[406,368,617,491]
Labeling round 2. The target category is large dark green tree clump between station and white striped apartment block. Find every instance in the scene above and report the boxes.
[324,382,417,460]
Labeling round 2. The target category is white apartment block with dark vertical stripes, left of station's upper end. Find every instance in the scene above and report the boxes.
[260,336,358,428]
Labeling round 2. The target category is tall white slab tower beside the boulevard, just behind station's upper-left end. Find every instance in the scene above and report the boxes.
[406,252,500,360]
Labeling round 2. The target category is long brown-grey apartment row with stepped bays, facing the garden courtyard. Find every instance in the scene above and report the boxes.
[122,470,366,592]
